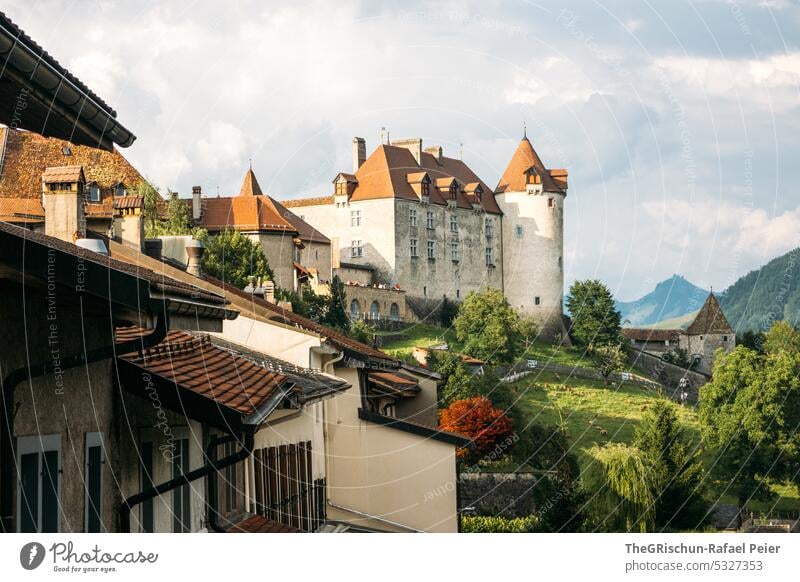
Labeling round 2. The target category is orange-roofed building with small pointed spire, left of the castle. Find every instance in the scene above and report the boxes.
[191,168,331,291]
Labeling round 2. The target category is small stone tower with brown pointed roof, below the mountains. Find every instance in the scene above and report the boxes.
[679,292,736,374]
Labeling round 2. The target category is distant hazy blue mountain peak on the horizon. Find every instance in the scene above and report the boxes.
[616,275,708,327]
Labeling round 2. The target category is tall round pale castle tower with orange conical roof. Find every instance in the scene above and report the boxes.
[495,135,567,340]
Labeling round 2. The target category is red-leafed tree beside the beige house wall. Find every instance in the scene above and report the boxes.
[439,396,514,457]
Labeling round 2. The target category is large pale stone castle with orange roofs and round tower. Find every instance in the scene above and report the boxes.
[283,136,567,338]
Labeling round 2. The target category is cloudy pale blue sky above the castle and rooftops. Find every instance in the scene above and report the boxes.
[3,0,800,300]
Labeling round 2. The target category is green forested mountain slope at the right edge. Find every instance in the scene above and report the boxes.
[719,247,800,333]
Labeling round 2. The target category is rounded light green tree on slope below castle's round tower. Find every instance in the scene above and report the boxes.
[453,289,524,364]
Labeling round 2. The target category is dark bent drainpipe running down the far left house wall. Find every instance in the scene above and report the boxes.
[0,312,169,532]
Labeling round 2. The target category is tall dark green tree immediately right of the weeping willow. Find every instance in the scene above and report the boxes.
[633,400,708,530]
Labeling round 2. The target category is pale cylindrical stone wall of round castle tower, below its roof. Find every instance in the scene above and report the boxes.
[496,187,564,338]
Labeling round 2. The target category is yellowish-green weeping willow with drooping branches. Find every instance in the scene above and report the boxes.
[583,443,656,532]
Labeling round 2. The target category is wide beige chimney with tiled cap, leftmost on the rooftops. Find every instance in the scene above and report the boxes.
[42,166,86,243]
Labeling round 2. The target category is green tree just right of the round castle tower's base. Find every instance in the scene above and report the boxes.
[567,280,621,348]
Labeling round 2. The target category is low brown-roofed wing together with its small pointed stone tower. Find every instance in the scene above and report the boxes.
[622,293,736,375]
